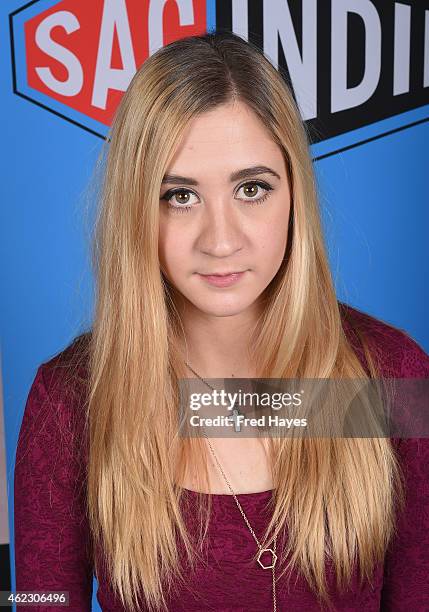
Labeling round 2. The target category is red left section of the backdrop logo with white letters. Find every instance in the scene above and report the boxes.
[19,0,206,126]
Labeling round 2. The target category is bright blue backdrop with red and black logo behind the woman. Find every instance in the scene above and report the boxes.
[0,0,429,610]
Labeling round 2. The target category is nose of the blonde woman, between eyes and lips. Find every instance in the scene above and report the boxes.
[197,199,244,257]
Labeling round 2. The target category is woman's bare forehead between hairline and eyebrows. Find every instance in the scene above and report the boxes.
[170,102,282,170]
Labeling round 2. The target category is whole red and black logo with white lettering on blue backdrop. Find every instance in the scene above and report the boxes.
[10,0,429,152]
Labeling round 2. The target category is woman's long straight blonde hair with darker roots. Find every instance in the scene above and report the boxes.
[86,33,402,610]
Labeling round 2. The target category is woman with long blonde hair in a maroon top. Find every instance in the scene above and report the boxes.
[15,33,429,611]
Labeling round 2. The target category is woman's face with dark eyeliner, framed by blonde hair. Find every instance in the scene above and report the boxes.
[159,98,291,316]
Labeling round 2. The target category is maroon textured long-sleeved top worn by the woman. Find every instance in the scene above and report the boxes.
[15,304,429,612]
